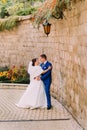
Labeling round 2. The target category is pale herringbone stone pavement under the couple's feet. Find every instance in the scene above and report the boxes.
[0,89,83,130]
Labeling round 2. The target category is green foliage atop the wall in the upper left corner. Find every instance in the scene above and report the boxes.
[0,0,37,31]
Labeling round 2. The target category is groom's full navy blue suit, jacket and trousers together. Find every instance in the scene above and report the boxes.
[41,61,52,107]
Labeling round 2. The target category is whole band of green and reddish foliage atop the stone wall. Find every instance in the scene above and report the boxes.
[0,0,84,31]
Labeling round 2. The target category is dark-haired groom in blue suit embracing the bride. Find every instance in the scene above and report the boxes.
[40,54,52,110]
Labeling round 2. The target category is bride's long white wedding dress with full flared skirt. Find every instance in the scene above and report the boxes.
[16,62,47,109]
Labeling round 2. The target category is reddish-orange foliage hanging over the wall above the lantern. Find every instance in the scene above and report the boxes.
[35,0,83,26]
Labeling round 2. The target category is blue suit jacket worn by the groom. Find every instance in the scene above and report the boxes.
[41,61,52,85]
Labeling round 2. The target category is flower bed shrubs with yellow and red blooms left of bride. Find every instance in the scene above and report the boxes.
[0,65,29,83]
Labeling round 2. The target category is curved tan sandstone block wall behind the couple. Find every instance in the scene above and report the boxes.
[0,0,87,128]
